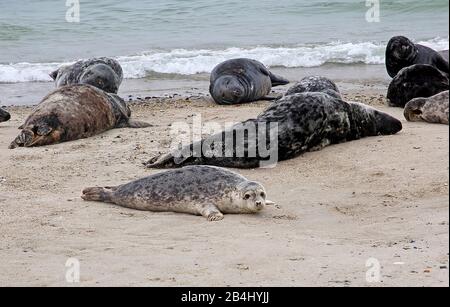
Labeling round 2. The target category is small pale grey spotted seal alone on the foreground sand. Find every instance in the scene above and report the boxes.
[81,166,273,221]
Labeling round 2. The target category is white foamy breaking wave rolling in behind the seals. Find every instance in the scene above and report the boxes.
[0,38,449,83]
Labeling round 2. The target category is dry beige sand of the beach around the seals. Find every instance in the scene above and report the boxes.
[0,87,449,286]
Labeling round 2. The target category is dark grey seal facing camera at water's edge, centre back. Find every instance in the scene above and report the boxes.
[209,59,289,105]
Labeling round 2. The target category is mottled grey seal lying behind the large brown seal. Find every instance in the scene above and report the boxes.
[50,58,123,94]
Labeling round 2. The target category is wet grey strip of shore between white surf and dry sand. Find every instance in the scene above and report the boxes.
[0,64,390,107]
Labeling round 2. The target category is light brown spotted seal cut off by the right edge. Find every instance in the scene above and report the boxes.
[404,91,449,125]
